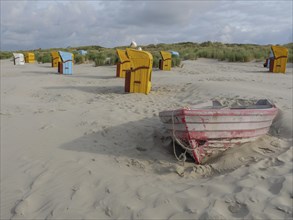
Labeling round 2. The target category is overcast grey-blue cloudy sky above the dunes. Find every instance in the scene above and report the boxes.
[1,0,293,50]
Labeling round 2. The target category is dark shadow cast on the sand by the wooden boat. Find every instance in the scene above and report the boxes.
[60,117,188,173]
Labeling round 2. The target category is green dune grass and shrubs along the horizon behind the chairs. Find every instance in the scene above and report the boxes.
[0,41,293,67]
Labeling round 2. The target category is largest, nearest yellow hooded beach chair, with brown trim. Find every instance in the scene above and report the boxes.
[125,48,153,94]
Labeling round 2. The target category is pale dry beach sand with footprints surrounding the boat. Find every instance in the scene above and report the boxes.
[0,59,293,219]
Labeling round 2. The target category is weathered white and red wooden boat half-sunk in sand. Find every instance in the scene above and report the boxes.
[159,99,278,164]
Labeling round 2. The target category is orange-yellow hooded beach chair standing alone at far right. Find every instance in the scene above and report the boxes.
[269,46,288,73]
